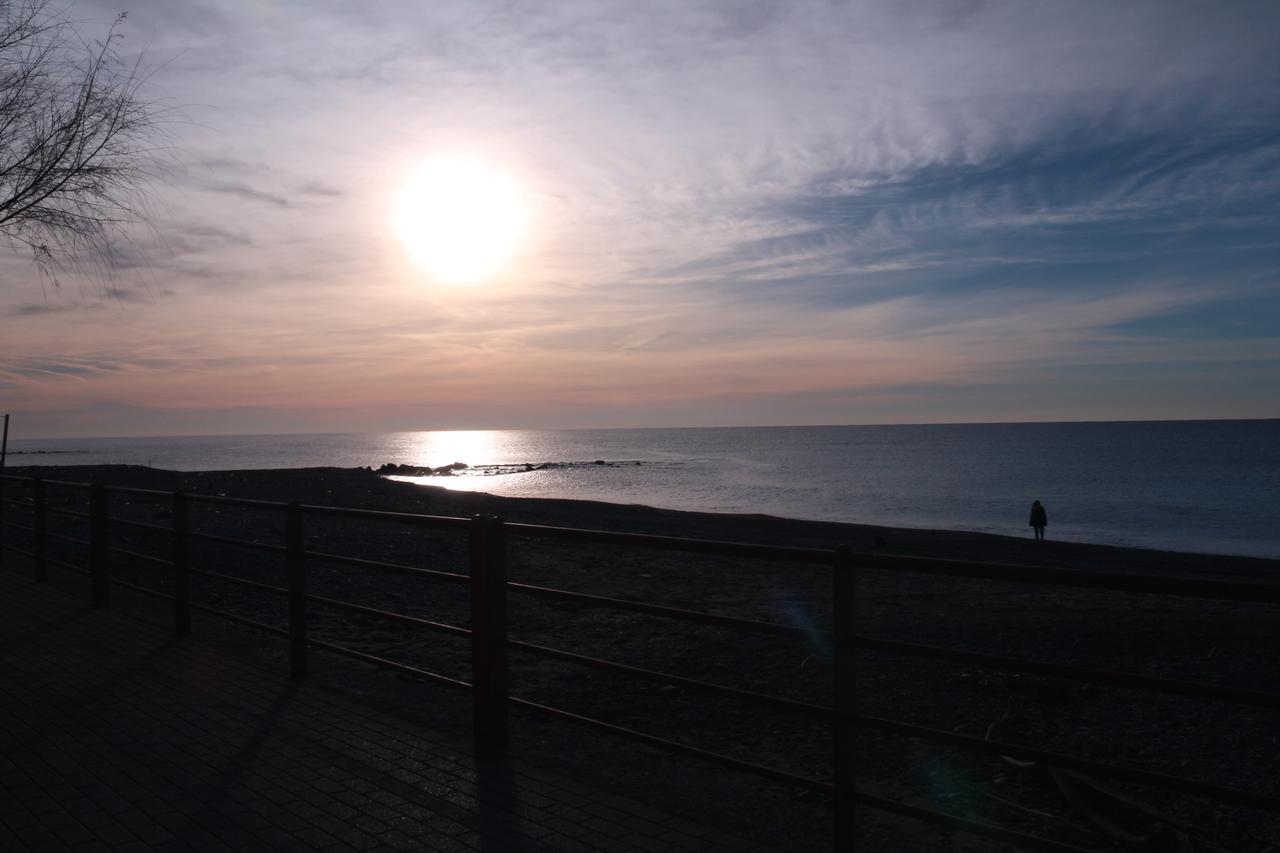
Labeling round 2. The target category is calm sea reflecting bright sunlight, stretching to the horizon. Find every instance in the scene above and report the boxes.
[8,420,1280,558]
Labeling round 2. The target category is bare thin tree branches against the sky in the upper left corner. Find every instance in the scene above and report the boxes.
[0,0,160,268]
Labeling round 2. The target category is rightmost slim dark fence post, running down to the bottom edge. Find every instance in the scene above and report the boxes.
[831,546,858,853]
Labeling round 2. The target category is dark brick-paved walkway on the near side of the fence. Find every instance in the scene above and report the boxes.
[0,566,764,853]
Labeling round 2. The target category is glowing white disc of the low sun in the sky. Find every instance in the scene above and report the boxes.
[396,158,527,283]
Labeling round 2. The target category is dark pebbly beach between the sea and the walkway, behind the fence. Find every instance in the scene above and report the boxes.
[6,466,1280,849]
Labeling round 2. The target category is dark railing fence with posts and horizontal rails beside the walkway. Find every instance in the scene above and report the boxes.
[0,475,1280,853]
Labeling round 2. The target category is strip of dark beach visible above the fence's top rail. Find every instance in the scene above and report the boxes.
[5,465,1280,579]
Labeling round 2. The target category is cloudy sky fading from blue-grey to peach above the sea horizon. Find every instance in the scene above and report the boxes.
[0,0,1280,437]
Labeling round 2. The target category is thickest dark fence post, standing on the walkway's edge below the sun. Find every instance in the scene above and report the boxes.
[470,515,509,754]
